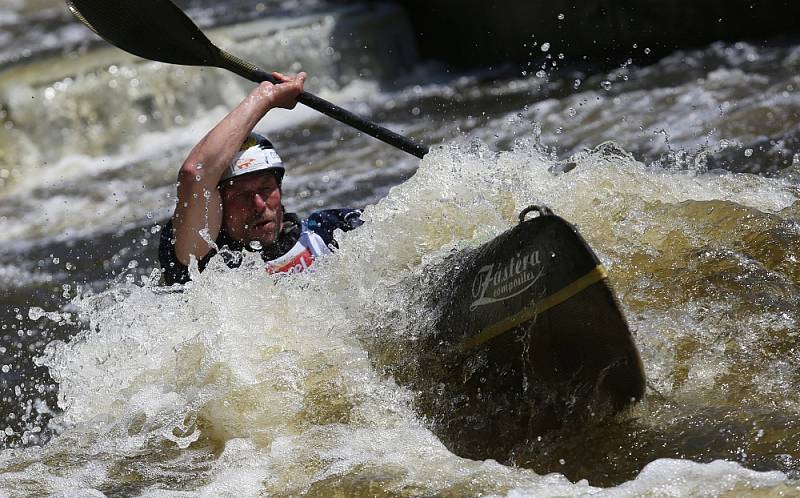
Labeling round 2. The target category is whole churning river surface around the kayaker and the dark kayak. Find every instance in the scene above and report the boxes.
[0,0,800,497]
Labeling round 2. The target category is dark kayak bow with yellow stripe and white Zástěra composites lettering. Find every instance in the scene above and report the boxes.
[407,206,645,459]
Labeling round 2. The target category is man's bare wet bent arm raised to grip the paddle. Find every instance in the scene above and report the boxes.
[172,73,305,265]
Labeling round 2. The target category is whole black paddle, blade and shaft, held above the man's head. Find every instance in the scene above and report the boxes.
[66,0,428,158]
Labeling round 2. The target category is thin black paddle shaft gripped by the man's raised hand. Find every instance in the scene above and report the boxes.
[218,51,428,159]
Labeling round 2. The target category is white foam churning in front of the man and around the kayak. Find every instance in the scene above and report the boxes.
[0,144,797,496]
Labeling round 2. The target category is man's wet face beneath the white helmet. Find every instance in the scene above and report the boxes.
[220,172,283,245]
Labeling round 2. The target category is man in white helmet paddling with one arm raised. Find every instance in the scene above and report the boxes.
[159,73,362,285]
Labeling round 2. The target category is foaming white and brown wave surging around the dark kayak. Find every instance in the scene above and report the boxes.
[0,143,800,496]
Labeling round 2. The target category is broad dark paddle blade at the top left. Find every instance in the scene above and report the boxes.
[67,0,220,66]
